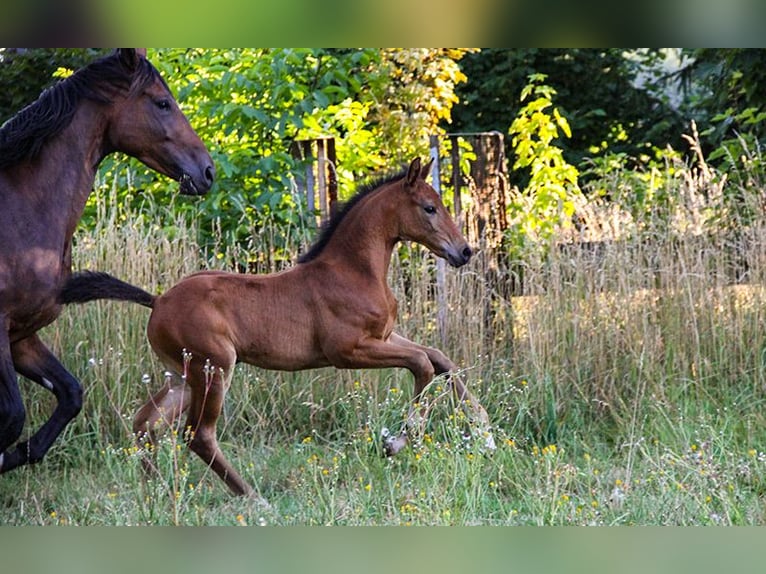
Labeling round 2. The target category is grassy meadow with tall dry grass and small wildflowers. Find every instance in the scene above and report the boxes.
[0,161,766,526]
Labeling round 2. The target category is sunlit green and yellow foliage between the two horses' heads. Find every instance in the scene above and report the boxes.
[79,49,474,255]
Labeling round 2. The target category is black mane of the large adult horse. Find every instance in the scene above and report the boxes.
[0,52,164,169]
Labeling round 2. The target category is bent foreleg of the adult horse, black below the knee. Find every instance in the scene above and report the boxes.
[2,335,82,471]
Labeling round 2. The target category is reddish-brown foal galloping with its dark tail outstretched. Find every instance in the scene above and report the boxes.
[60,159,494,500]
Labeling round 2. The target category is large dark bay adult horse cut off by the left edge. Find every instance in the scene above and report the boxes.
[0,49,215,472]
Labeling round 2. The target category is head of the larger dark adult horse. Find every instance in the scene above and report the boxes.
[107,48,215,195]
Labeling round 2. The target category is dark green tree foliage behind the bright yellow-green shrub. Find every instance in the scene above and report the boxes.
[453,48,683,177]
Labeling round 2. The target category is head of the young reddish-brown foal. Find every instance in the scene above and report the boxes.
[399,158,473,267]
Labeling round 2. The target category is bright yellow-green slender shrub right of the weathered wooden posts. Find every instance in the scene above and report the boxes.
[508,74,581,252]
